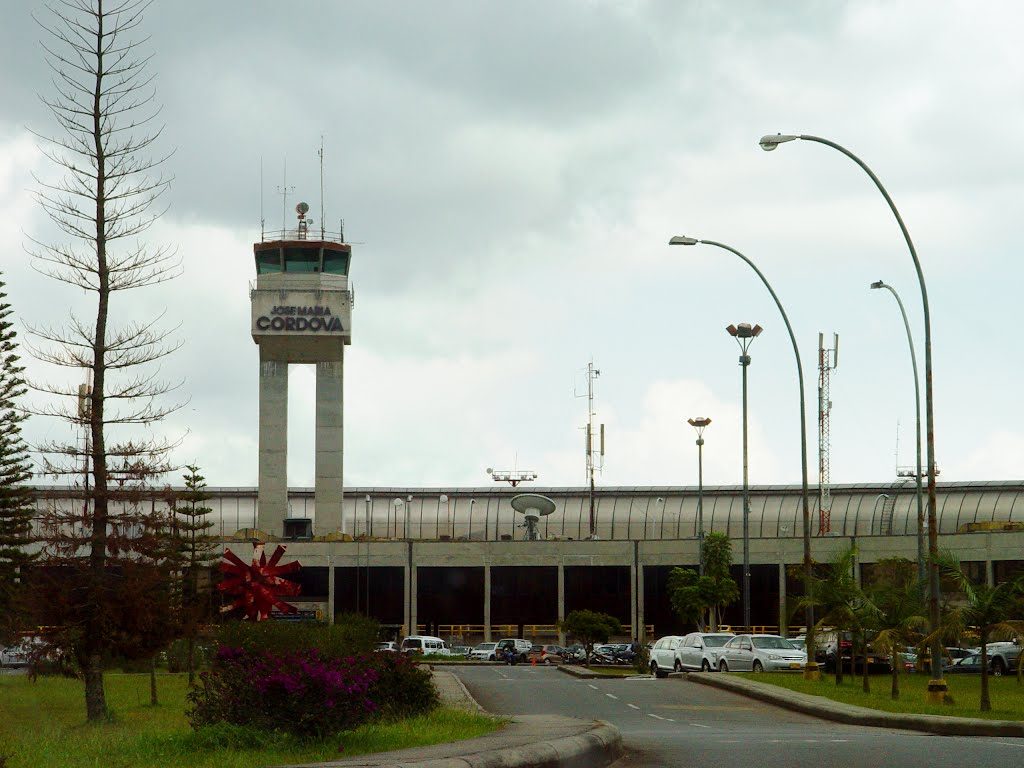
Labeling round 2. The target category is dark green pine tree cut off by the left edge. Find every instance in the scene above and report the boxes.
[0,279,34,633]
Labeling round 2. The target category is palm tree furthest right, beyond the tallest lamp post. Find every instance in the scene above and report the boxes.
[936,551,1024,712]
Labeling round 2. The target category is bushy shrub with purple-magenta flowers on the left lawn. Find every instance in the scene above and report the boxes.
[188,646,378,738]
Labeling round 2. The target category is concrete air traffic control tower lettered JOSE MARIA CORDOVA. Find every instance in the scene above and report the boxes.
[249,203,353,538]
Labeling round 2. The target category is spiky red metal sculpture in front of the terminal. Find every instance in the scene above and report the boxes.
[217,544,302,622]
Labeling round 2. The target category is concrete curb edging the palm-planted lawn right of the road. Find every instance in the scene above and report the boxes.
[685,672,1024,738]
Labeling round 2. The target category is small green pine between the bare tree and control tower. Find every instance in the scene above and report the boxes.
[174,464,217,685]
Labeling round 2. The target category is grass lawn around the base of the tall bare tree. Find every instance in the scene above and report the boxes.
[0,673,501,768]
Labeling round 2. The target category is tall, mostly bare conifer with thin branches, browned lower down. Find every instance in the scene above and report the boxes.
[29,0,180,721]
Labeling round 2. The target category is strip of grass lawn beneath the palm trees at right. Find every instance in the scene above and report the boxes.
[751,673,1024,720]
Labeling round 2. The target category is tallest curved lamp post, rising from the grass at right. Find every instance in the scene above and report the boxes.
[759,133,947,701]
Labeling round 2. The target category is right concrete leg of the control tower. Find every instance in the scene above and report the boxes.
[315,360,344,535]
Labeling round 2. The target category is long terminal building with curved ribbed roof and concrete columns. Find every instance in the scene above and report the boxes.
[29,480,1024,642]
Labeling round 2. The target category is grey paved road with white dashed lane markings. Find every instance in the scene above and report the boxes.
[452,666,1024,768]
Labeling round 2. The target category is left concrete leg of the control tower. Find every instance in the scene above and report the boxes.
[257,348,288,536]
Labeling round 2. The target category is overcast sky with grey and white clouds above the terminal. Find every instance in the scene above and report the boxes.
[0,0,1024,487]
